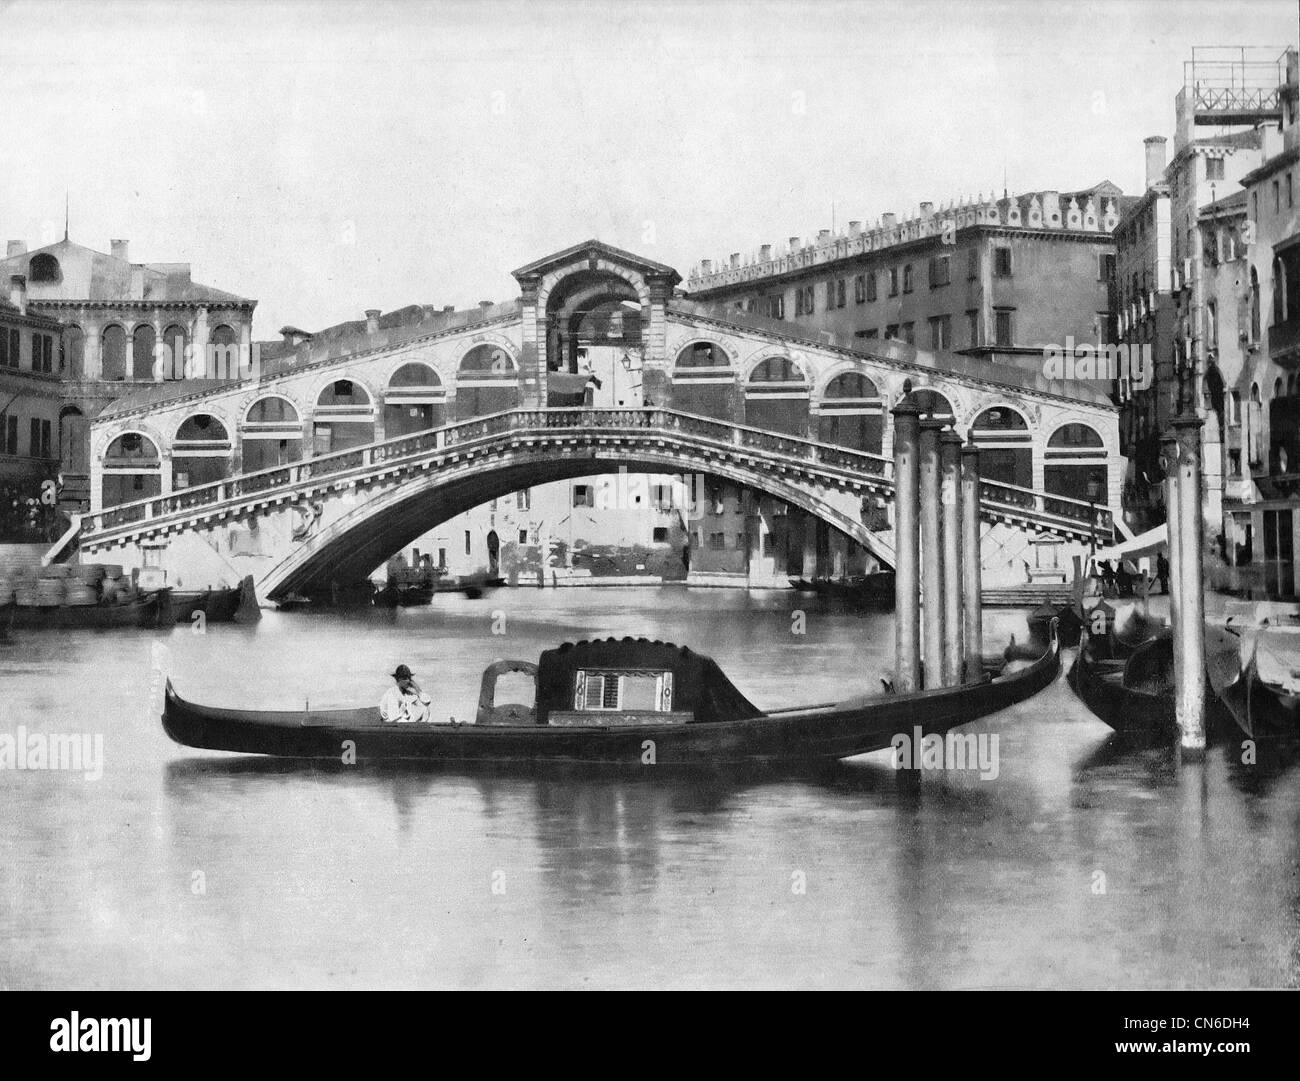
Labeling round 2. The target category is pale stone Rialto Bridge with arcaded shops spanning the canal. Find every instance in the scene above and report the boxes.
[65,242,1121,599]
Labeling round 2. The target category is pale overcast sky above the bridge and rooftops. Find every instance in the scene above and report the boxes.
[0,0,1297,338]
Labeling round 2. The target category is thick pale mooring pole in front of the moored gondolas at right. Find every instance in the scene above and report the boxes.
[1170,413,1205,759]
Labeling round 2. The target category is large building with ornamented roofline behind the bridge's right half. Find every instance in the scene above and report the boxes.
[686,181,1127,372]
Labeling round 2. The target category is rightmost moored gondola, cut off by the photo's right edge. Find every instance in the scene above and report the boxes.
[1205,626,1300,739]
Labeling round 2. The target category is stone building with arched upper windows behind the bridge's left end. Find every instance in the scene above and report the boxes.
[0,236,256,502]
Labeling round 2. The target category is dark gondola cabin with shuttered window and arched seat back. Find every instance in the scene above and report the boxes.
[477,638,762,728]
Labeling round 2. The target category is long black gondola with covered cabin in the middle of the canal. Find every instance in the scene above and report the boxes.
[163,621,1061,768]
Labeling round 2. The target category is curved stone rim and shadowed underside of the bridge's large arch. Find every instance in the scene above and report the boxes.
[257,443,893,599]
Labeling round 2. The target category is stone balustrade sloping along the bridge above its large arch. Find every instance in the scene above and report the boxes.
[82,407,1113,537]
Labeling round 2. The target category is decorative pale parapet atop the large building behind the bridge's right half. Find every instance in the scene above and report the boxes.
[686,191,1119,292]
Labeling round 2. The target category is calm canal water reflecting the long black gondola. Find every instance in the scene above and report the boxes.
[0,587,1300,989]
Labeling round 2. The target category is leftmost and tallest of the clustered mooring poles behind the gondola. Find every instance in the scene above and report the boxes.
[893,398,920,694]
